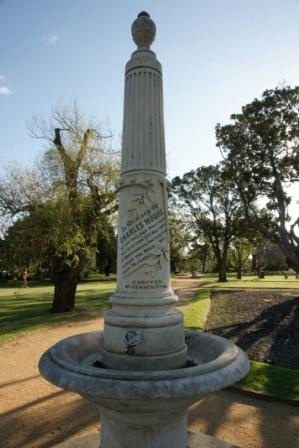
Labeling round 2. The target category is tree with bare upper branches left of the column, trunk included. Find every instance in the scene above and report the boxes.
[0,105,118,312]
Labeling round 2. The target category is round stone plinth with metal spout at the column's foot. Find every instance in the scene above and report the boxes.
[101,300,187,372]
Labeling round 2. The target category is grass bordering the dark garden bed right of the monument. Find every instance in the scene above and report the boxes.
[184,276,299,401]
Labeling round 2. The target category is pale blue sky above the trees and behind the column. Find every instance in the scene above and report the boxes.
[0,0,299,193]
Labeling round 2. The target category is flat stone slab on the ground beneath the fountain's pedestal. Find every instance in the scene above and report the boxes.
[53,432,240,448]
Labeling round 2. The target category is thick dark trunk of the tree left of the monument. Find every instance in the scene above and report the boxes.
[52,267,79,313]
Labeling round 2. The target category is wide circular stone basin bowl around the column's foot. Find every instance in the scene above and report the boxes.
[39,331,249,403]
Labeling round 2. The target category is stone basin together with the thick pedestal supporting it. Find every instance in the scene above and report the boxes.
[39,332,249,448]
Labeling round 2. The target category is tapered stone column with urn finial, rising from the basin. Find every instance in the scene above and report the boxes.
[103,12,187,370]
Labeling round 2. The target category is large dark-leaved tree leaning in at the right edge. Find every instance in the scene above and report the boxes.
[216,86,299,271]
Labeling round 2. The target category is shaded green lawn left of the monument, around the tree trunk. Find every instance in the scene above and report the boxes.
[0,278,115,342]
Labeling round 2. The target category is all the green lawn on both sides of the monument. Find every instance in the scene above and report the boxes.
[0,275,299,400]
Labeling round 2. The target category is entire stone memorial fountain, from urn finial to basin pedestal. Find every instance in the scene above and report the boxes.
[39,12,249,448]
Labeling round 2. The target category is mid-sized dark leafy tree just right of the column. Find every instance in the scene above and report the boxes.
[172,165,242,282]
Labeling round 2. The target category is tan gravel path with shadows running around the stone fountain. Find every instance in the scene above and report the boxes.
[0,279,299,448]
